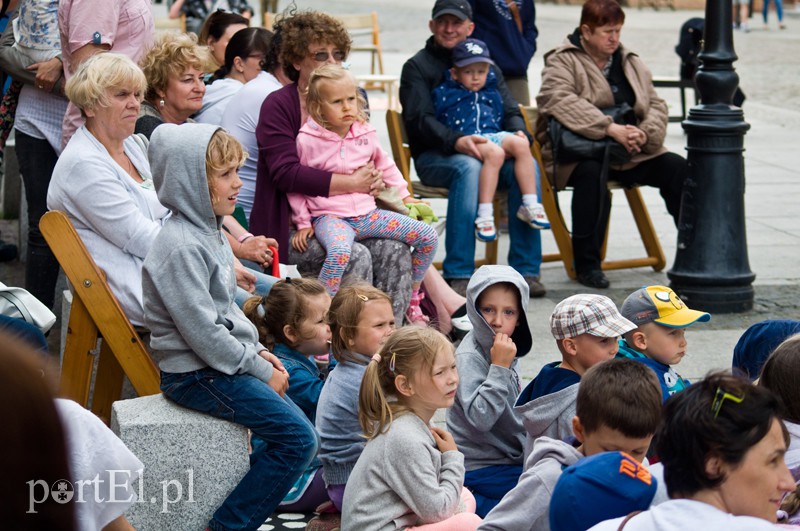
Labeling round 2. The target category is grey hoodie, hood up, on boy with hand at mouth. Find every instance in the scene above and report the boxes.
[447,265,533,470]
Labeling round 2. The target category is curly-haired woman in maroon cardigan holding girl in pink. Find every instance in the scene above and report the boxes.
[255,11,418,322]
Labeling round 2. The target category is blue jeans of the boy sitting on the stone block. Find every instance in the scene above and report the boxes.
[161,368,319,531]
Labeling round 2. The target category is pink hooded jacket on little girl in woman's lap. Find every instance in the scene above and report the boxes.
[287,118,410,229]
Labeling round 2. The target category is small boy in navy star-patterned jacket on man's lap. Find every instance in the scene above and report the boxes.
[433,39,550,241]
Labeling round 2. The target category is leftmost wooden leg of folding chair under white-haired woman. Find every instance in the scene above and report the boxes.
[59,297,98,407]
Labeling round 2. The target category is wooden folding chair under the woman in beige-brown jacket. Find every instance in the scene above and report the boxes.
[519,105,667,280]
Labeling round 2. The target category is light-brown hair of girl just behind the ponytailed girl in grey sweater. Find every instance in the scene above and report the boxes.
[328,282,392,362]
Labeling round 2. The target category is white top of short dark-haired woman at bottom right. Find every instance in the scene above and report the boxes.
[589,499,775,531]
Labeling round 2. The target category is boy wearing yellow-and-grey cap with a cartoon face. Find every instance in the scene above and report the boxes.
[617,286,711,400]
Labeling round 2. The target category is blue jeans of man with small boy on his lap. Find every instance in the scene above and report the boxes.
[414,151,542,279]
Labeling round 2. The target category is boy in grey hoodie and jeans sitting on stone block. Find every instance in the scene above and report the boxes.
[142,124,317,530]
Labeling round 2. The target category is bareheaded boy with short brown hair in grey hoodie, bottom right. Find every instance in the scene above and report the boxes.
[478,359,661,531]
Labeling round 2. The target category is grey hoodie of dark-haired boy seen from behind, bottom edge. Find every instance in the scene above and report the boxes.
[478,437,583,531]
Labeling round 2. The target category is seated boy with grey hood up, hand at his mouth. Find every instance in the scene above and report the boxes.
[447,265,533,517]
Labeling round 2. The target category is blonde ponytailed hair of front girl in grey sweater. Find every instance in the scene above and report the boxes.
[358,326,453,439]
